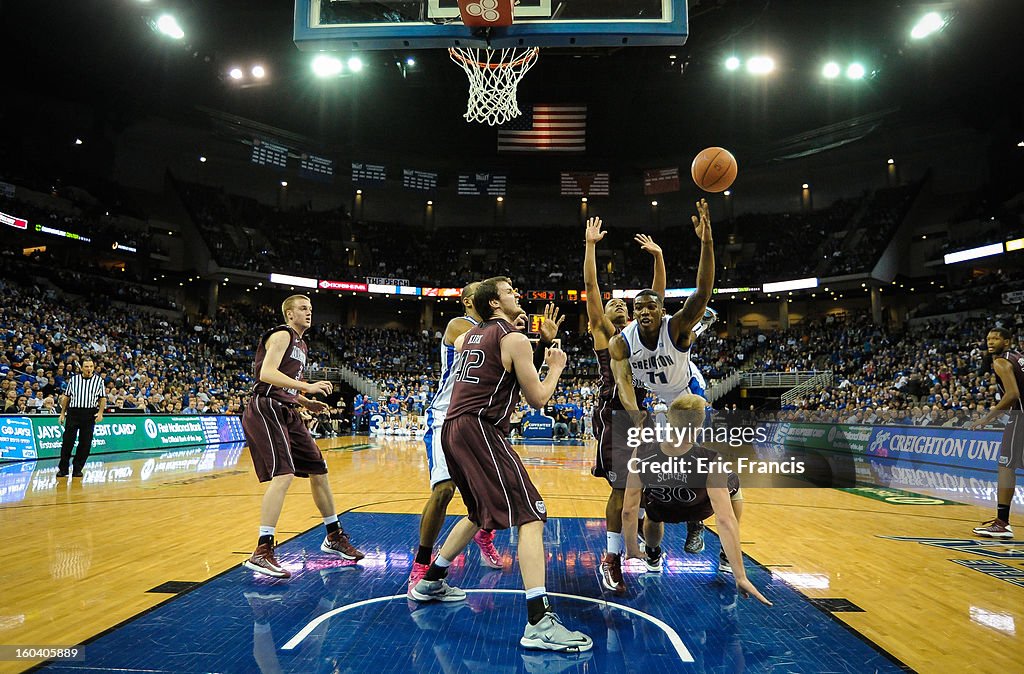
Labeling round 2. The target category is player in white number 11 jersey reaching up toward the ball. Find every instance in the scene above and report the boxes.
[608,199,715,554]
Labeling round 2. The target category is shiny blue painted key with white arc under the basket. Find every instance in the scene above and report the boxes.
[36,512,903,674]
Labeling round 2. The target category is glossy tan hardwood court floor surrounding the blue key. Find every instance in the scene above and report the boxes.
[0,437,1024,672]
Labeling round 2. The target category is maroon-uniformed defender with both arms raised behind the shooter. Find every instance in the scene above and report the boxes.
[583,217,666,593]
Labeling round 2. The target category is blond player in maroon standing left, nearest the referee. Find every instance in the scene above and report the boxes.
[242,295,366,578]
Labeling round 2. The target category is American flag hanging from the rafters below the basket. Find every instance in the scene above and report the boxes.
[498,104,587,153]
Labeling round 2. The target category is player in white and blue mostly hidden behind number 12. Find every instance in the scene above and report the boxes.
[409,282,502,588]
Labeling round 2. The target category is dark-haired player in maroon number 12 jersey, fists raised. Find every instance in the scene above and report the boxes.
[410,277,594,652]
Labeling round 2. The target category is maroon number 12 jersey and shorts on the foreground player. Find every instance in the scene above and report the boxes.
[441,319,548,529]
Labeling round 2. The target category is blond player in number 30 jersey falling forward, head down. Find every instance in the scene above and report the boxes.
[623,393,771,605]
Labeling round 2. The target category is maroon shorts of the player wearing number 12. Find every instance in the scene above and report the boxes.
[441,415,548,529]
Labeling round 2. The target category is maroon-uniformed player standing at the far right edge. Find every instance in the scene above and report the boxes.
[972,328,1024,539]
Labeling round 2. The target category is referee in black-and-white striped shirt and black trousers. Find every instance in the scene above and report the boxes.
[57,357,106,477]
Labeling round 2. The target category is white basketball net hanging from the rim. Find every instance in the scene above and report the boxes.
[449,47,541,126]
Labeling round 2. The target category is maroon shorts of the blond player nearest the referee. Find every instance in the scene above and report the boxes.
[242,395,327,482]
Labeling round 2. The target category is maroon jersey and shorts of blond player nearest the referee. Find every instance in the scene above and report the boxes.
[242,326,327,482]
